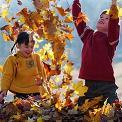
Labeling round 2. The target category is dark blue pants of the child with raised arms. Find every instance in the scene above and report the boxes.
[78,80,118,106]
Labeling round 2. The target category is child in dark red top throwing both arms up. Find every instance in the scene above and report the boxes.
[72,0,120,106]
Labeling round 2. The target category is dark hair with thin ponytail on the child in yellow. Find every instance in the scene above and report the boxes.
[11,32,29,53]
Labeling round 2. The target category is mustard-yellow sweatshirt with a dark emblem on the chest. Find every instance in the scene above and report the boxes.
[1,52,46,94]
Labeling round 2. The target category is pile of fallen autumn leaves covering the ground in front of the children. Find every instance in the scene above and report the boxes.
[0,96,122,122]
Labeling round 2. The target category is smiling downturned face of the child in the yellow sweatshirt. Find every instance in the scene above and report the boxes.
[18,42,34,58]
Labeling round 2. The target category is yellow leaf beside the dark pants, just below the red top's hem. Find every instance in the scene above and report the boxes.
[72,81,88,96]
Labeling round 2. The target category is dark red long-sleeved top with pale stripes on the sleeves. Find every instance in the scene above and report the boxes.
[72,0,120,82]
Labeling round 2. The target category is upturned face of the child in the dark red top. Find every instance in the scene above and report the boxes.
[97,14,110,33]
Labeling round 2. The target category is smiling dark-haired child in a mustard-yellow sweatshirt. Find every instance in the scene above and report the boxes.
[0,32,47,101]
